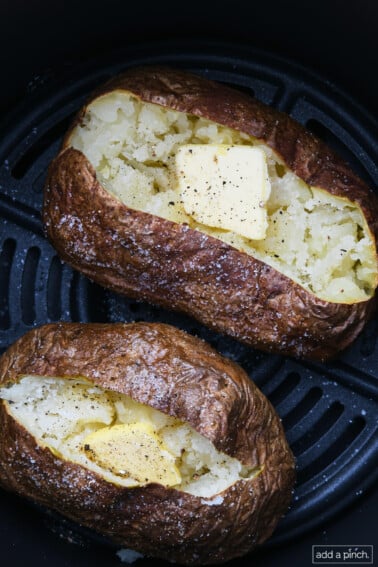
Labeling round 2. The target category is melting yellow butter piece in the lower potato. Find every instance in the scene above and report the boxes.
[84,422,181,486]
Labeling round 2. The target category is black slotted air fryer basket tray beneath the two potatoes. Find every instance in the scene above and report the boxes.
[0,42,378,556]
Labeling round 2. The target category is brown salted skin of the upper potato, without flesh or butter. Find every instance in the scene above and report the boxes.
[43,67,378,361]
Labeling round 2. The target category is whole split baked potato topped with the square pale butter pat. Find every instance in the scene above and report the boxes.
[43,67,378,360]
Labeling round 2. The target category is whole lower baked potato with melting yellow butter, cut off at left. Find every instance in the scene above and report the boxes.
[0,323,295,565]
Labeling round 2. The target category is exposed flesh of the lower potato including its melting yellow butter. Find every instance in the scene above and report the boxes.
[0,376,260,498]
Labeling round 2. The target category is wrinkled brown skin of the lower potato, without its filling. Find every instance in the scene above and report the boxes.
[0,323,295,565]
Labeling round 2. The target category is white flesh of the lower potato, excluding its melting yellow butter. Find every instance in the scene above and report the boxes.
[0,376,259,498]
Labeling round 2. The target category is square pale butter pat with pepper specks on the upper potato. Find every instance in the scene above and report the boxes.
[176,144,270,240]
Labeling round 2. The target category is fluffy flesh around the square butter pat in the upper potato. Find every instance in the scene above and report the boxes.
[69,91,378,303]
